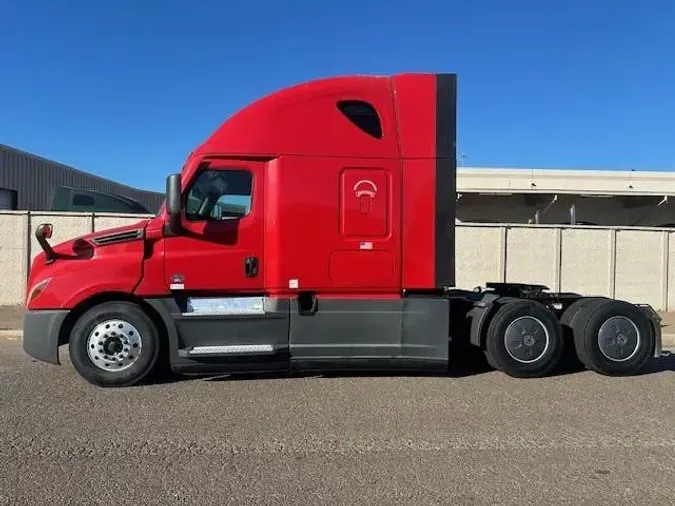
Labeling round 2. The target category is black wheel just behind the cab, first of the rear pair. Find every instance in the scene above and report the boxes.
[485,300,565,378]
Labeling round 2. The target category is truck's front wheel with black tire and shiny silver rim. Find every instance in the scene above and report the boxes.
[69,302,160,387]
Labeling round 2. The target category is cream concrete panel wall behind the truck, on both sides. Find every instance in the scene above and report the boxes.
[0,211,675,310]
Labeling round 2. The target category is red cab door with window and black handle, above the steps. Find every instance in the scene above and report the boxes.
[164,161,265,295]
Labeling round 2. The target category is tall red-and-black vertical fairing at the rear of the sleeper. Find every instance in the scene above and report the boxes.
[392,74,456,290]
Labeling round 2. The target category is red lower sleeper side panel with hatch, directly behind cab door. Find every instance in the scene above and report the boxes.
[265,157,401,294]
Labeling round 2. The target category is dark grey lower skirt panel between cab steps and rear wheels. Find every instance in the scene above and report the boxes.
[290,296,450,370]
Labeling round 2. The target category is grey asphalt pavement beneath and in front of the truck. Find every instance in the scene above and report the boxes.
[0,339,675,506]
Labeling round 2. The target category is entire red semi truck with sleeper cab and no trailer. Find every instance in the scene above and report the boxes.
[23,73,661,386]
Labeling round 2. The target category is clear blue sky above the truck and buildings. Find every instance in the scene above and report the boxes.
[0,0,675,191]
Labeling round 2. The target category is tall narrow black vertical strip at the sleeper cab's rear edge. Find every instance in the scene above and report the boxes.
[434,74,457,288]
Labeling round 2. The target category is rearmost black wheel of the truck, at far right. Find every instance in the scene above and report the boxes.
[571,299,656,376]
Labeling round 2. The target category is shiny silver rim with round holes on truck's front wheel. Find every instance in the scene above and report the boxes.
[87,319,143,372]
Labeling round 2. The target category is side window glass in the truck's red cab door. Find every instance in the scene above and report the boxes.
[185,169,253,221]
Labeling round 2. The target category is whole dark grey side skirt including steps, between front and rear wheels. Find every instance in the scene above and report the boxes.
[148,294,450,373]
